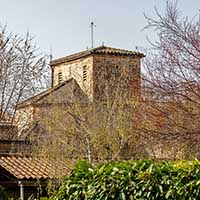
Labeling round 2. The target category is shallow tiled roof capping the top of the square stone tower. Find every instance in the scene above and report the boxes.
[50,46,145,67]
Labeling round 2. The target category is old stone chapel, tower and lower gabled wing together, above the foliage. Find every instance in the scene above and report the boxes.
[17,46,144,133]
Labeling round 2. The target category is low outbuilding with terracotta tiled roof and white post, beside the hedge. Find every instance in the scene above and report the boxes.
[0,155,69,200]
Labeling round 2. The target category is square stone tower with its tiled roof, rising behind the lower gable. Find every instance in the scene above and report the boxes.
[51,47,144,100]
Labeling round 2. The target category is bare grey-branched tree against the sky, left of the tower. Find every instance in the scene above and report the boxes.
[0,26,49,137]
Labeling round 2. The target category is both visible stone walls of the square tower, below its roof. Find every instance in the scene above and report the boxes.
[53,54,141,99]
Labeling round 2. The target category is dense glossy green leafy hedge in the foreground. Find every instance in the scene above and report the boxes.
[51,160,200,200]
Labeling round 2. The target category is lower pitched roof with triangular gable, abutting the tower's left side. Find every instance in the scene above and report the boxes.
[17,78,87,108]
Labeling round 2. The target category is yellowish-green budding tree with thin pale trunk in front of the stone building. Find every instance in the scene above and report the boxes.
[31,63,145,163]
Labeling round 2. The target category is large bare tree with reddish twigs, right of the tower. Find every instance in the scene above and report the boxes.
[144,1,200,159]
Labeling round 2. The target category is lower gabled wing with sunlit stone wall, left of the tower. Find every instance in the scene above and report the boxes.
[16,78,88,137]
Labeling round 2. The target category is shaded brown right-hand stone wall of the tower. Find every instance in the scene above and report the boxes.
[93,55,141,99]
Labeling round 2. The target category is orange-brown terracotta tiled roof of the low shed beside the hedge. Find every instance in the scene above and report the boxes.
[0,156,69,179]
